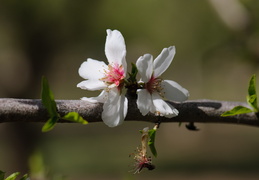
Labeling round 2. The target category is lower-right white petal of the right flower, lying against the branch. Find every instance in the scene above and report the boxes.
[151,93,179,118]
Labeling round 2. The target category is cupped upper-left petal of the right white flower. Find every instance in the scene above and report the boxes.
[136,54,153,82]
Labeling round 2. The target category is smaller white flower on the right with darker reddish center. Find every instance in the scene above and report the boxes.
[136,46,189,118]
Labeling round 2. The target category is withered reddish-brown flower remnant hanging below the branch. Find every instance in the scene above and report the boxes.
[134,127,155,174]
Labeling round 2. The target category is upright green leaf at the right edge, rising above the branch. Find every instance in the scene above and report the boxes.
[247,74,258,112]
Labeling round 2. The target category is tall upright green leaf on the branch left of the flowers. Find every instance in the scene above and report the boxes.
[41,77,59,117]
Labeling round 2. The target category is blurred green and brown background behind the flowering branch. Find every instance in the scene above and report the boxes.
[0,0,259,180]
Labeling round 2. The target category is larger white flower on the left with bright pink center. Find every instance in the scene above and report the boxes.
[77,29,128,127]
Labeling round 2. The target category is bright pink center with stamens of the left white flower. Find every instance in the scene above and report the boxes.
[101,64,125,87]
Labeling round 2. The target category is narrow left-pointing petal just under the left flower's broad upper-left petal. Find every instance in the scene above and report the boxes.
[77,80,107,91]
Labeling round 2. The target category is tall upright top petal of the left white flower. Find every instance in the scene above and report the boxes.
[105,29,127,65]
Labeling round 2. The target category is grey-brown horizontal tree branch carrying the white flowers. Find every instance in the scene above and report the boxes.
[0,98,259,127]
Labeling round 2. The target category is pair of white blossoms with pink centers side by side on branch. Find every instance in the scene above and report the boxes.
[77,29,189,127]
